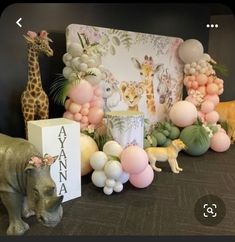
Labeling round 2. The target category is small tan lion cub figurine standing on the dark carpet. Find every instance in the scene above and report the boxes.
[145,139,186,173]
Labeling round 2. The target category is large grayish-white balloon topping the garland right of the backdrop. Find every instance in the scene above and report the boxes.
[178,39,204,64]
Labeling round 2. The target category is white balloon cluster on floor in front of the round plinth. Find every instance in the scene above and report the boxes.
[90,141,129,195]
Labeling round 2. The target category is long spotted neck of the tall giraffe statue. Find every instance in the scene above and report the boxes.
[26,46,42,96]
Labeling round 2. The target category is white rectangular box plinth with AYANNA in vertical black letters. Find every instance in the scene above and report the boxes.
[28,118,81,202]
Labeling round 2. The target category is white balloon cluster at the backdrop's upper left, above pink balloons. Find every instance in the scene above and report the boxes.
[63,35,104,85]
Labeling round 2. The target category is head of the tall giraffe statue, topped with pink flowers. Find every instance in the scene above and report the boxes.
[24,30,53,56]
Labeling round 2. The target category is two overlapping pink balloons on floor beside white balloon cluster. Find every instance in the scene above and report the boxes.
[121,145,154,188]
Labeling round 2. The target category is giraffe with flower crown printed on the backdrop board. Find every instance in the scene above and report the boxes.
[131,55,162,113]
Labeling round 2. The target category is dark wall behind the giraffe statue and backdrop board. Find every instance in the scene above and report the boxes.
[0,3,231,137]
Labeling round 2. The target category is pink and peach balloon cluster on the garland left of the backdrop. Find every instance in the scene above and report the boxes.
[63,80,104,130]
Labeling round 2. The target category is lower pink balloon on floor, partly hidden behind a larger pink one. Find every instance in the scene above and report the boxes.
[129,165,154,188]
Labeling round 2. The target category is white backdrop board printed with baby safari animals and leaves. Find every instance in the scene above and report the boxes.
[66,24,183,123]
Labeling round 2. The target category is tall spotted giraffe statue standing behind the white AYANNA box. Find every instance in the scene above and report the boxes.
[21,30,53,138]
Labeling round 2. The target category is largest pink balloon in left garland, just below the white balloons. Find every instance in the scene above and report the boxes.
[68,80,93,104]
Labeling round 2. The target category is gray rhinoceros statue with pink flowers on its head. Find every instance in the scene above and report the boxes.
[0,134,63,235]
